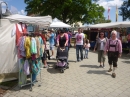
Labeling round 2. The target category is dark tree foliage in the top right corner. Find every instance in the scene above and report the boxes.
[119,0,130,21]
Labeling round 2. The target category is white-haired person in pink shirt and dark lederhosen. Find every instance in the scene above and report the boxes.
[104,30,122,78]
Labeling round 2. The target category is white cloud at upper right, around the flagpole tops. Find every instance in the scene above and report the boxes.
[97,0,123,10]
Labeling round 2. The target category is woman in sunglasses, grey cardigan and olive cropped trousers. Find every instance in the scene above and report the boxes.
[94,32,107,68]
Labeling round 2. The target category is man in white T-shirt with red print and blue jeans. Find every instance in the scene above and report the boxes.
[74,28,85,62]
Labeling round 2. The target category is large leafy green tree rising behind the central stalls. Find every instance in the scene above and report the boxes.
[24,0,104,24]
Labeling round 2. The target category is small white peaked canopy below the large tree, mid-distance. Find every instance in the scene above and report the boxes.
[50,18,71,28]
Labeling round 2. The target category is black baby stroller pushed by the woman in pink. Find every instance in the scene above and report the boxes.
[55,47,69,73]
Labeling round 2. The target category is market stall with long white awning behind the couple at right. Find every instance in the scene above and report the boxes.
[84,21,130,49]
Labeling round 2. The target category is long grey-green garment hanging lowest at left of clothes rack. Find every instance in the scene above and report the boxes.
[19,58,27,85]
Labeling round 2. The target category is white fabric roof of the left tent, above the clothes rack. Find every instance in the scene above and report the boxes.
[5,14,52,26]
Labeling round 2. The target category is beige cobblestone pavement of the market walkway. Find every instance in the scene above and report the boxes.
[4,49,130,97]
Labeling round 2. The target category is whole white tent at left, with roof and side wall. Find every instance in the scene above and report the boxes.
[0,15,52,82]
